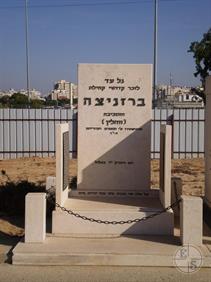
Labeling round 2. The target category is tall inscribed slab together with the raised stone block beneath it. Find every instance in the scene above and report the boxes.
[53,64,174,236]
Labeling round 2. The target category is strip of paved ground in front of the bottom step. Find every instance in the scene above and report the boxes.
[0,264,211,282]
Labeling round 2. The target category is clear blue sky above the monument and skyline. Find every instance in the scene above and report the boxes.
[0,0,211,94]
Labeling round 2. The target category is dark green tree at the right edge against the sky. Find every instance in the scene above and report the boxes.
[188,28,211,101]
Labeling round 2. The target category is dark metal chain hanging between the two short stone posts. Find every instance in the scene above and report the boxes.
[47,192,181,225]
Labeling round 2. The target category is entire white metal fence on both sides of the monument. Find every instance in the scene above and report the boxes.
[0,109,204,159]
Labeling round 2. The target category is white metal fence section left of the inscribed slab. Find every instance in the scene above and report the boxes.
[0,109,77,159]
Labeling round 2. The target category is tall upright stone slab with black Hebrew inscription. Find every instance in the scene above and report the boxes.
[78,64,152,191]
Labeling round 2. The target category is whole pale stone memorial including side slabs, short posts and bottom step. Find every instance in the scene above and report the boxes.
[13,64,211,266]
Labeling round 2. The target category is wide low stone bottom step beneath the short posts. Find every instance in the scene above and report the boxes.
[13,236,211,267]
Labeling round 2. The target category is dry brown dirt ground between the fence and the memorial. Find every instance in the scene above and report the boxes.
[0,157,204,236]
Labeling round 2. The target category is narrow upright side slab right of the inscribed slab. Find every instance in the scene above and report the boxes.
[159,125,172,208]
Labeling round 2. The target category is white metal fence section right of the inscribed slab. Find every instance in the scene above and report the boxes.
[151,108,205,159]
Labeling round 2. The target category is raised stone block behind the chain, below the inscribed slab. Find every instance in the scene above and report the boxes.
[52,196,174,237]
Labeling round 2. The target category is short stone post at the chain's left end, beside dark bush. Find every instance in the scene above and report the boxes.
[25,193,46,243]
